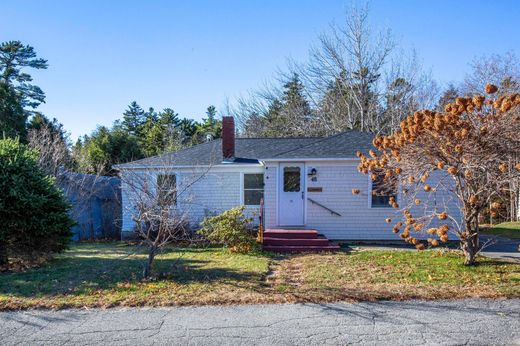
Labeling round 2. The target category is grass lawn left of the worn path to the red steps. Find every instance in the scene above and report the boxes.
[0,243,269,308]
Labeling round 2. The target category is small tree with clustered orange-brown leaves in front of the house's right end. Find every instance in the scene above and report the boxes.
[358,84,520,265]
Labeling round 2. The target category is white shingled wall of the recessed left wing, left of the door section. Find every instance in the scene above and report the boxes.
[121,165,264,239]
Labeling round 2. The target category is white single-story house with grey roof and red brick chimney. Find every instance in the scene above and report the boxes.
[116,117,462,247]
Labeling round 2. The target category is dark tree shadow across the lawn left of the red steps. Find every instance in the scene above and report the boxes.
[0,249,263,298]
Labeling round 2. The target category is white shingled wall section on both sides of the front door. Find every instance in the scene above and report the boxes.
[265,161,459,240]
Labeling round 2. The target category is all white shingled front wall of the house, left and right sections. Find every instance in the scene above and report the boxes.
[122,160,460,240]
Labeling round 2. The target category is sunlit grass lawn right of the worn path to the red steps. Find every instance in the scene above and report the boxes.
[280,250,520,300]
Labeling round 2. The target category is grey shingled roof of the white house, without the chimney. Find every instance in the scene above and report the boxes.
[115,130,373,169]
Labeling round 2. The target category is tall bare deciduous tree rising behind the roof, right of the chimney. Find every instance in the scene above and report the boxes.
[234,6,438,137]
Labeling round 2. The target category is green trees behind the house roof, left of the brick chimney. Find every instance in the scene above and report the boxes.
[73,101,222,174]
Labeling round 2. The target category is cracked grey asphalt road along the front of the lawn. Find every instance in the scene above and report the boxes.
[0,299,520,345]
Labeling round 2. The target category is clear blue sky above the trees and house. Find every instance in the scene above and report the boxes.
[0,0,520,138]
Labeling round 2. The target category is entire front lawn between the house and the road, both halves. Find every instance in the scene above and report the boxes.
[0,243,520,309]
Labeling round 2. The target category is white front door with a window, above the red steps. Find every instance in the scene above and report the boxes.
[278,163,305,226]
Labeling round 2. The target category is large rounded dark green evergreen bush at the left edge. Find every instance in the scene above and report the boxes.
[0,139,74,265]
